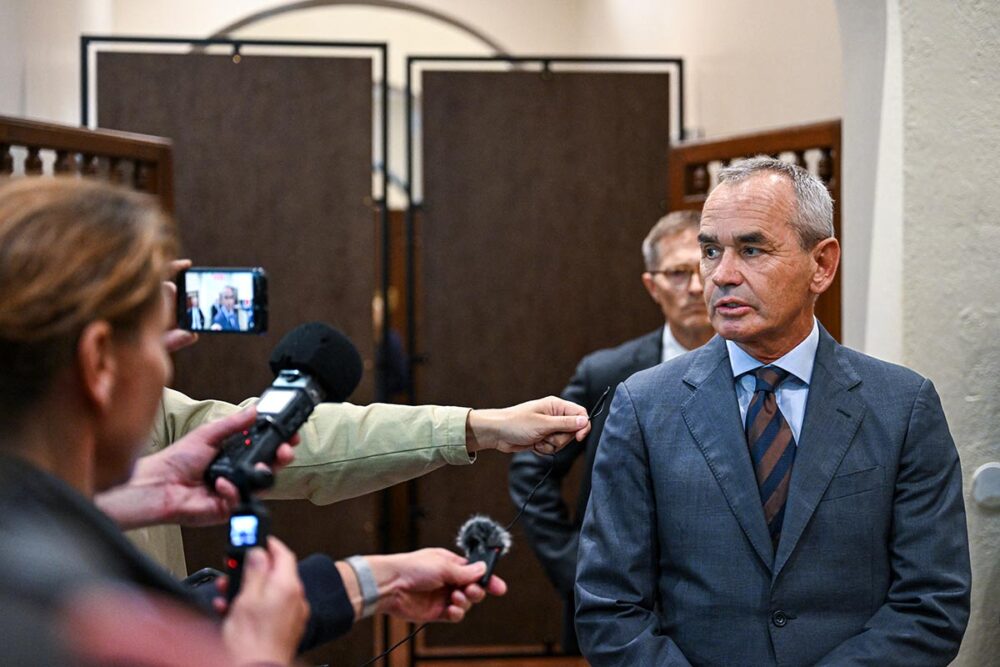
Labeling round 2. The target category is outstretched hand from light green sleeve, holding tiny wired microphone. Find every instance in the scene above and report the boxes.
[465,396,590,454]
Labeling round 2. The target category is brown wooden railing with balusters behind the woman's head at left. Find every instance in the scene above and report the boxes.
[0,116,174,211]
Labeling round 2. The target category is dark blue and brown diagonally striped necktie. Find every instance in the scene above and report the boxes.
[746,366,795,550]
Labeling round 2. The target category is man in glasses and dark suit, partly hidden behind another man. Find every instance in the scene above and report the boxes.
[510,211,712,654]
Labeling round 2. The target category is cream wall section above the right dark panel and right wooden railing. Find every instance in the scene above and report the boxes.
[579,0,842,138]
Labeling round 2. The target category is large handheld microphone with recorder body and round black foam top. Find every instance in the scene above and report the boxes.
[205,322,363,498]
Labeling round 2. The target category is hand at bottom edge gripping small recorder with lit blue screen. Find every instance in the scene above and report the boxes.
[223,537,309,665]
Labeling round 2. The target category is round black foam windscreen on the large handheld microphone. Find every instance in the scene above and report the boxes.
[270,322,364,403]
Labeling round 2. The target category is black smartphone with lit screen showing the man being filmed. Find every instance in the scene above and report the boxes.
[177,266,267,334]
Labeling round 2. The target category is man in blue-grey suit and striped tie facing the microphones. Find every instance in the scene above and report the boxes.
[576,158,970,665]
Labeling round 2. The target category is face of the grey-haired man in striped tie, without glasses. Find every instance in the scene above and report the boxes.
[699,173,840,362]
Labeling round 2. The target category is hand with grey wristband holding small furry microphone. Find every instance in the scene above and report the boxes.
[337,549,507,623]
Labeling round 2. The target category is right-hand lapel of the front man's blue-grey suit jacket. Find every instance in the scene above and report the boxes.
[773,327,865,578]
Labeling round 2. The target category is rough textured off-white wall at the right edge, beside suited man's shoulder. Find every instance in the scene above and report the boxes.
[900,0,1000,665]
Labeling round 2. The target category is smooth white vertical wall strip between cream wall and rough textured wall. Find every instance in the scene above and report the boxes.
[837,0,903,363]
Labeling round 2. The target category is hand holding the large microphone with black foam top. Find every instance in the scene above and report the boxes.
[94,407,297,530]
